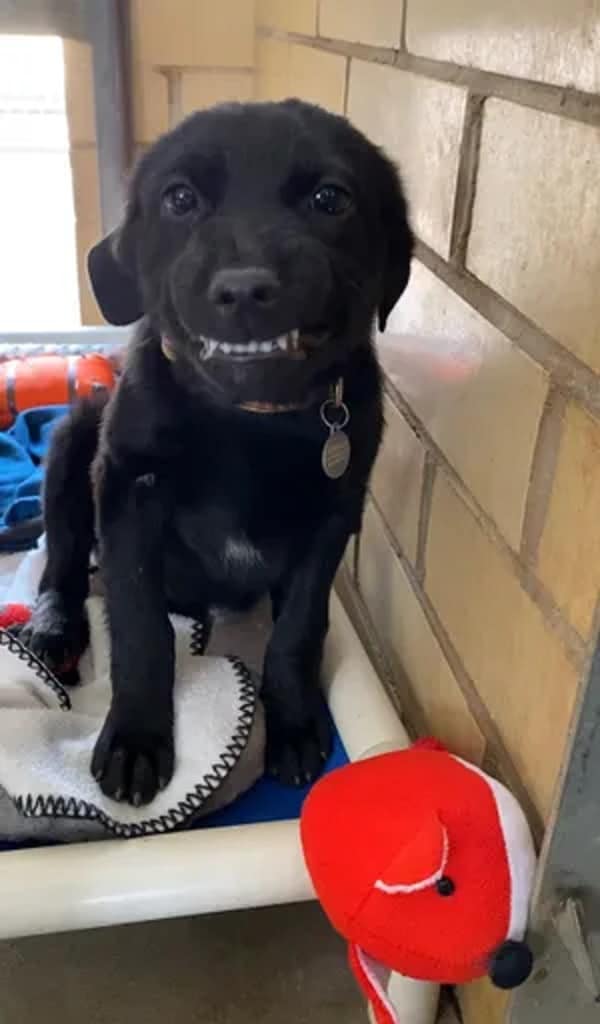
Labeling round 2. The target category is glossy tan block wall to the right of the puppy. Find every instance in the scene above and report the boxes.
[256,0,600,1024]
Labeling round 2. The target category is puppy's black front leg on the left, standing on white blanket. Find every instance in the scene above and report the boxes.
[92,457,174,806]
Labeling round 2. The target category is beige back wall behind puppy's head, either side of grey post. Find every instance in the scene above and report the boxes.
[65,0,255,325]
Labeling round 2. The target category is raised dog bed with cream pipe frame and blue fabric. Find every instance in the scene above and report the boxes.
[0,329,437,1024]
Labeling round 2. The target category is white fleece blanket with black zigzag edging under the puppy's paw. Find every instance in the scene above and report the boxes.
[0,597,264,839]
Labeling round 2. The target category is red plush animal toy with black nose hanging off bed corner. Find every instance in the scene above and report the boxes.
[301,740,535,1024]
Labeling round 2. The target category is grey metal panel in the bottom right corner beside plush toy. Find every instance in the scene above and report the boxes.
[511,645,600,1024]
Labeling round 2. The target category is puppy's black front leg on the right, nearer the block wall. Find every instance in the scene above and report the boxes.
[262,516,351,785]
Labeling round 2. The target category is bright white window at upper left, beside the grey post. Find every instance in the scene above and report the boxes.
[0,35,81,331]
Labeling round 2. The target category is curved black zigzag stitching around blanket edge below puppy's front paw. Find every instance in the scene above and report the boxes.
[14,657,257,839]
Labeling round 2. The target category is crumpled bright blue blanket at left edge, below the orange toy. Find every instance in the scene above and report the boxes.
[0,406,69,551]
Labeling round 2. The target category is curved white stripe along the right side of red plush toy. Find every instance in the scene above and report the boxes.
[456,758,535,941]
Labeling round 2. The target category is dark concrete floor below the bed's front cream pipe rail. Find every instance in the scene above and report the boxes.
[0,904,367,1024]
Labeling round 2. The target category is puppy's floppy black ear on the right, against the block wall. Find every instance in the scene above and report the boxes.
[378,153,414,331]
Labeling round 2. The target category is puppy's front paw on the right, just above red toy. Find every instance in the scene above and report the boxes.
[266,702,333,786]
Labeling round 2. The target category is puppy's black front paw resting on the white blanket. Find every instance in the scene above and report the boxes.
[91,712,175,807]
